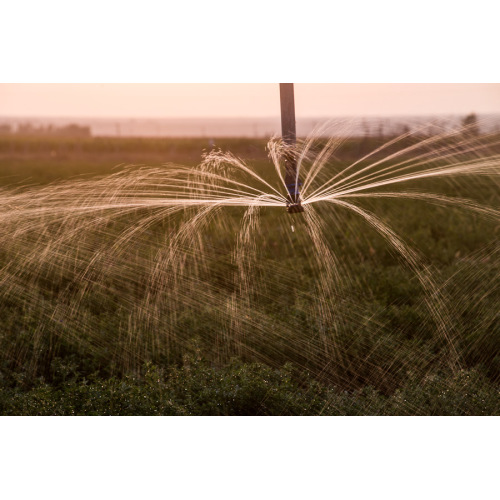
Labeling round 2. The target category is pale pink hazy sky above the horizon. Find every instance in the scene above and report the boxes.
[0,83,500,118]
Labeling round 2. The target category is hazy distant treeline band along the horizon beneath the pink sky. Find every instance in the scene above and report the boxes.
[0,113,492,140]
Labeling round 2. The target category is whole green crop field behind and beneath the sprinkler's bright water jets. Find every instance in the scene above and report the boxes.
[0,135,500,415]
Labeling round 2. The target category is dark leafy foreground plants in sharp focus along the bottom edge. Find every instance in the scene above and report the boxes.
[0,357,500,416]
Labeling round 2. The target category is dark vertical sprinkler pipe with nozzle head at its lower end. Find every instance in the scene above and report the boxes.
[280,83,304,214]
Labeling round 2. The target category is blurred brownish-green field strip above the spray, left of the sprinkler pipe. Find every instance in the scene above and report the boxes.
[0,135,266,186]
